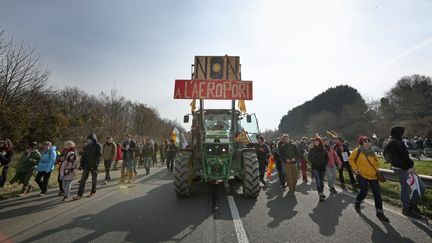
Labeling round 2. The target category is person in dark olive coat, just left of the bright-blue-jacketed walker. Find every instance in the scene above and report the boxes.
[10,142,41,197]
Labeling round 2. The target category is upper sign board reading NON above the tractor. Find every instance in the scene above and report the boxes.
[193,56,241,80]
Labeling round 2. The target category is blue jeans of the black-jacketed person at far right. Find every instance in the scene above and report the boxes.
[392,167,426,208]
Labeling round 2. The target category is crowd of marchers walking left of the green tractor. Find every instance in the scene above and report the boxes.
[0,133,178,200]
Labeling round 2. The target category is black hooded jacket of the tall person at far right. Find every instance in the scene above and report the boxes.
[384,126,414,170]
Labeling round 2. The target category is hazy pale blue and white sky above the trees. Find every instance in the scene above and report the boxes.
[0,0,432,130]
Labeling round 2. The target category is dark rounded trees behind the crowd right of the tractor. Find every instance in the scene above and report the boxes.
[278,74,432,140]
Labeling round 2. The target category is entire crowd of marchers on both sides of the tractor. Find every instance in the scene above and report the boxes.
[0,126,428,222]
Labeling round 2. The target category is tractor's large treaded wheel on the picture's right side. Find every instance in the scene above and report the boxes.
[243,151,261,198]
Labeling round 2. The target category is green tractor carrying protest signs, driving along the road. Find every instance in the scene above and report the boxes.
[173,56,261,198]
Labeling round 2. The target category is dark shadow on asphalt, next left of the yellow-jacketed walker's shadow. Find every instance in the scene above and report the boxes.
[309,193,352,236]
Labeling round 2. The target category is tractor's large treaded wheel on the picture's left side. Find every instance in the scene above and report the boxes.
[173,152,193,197]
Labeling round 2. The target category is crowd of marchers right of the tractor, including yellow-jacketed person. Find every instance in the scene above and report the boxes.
[255,126,426,222]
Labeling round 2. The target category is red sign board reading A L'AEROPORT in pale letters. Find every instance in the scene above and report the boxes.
[174,80,253,100]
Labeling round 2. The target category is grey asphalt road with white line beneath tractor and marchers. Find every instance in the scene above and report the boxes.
[0,167,432,242]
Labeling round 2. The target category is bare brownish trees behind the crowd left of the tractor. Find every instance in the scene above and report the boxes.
[0,32,180,146]
